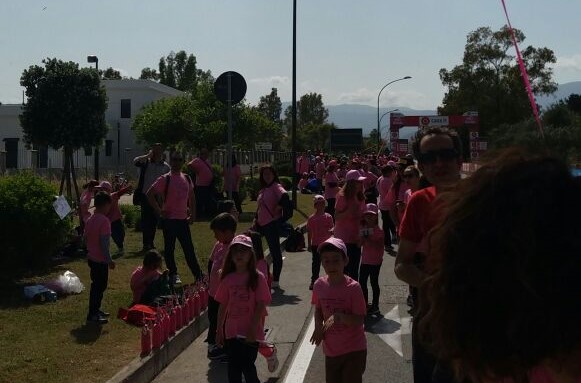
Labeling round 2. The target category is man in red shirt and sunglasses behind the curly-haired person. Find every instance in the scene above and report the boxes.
[394,127,462,383]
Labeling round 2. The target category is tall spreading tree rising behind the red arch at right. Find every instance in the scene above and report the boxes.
[438,26,556,134]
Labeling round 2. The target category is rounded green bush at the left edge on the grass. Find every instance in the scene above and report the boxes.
[0,173,72,270]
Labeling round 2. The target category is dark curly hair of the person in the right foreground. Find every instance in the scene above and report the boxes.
[419,150,581,382]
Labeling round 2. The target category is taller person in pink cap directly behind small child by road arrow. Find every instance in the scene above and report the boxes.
[335,170,365,281]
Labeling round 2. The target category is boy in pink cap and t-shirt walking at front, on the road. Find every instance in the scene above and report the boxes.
[311,237,367,383]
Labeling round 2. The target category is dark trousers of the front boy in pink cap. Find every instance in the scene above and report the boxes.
[325,350,367,383]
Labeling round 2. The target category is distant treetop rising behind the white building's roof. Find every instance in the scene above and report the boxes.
[139,50,198,94]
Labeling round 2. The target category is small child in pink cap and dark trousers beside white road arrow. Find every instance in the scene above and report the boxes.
[359,203,384,315]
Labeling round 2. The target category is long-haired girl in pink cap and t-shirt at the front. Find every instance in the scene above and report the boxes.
[215,235,271,383]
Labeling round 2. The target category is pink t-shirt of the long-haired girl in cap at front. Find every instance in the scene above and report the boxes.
[215,272,271,341]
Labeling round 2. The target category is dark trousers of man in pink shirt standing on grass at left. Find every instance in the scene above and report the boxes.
[163,219,202,280]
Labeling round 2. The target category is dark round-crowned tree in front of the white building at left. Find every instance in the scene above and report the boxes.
[20,58,107,198]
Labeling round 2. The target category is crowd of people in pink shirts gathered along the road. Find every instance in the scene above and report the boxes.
[78,127,581,383]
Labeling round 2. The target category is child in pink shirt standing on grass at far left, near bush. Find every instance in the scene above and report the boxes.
[84,192,115,324]
